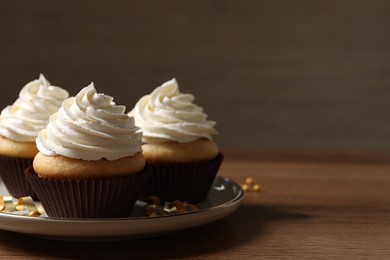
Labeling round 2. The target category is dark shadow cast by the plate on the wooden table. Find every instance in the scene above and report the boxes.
[0,205,309,259]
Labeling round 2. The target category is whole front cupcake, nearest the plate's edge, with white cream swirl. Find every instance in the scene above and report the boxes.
[25,84,149,218]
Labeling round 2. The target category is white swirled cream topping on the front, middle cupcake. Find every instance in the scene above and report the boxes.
[36,83,142,160]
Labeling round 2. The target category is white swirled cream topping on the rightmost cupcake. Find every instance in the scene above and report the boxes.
[130,79,216,143]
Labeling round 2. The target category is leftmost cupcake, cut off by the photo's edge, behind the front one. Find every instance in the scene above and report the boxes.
[0,74,69,199]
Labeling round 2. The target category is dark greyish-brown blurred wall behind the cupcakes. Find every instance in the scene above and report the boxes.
[0,0,390,152]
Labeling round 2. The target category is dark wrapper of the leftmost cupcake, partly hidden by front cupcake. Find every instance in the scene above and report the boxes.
[0,156,38,199]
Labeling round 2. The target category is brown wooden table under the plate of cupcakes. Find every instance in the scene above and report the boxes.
[0,151,390,259]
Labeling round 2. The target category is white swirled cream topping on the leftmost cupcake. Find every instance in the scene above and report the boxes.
[0,74,69,142]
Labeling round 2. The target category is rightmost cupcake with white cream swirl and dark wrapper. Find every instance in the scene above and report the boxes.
[129,79,223,203]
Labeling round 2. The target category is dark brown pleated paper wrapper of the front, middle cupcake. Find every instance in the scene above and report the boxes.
[25,167,149,218]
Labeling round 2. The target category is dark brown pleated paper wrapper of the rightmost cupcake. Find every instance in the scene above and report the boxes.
[141,154,223,203]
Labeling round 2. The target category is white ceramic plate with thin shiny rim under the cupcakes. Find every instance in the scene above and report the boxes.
[0,176,243,241]
